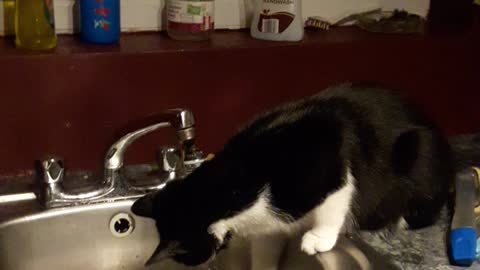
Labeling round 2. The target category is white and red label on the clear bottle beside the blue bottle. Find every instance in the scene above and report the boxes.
[167,0,215,33]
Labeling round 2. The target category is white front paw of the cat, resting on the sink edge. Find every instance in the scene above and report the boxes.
[301,231,338,255]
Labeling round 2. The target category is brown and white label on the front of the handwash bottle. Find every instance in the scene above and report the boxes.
[257,0,295,34]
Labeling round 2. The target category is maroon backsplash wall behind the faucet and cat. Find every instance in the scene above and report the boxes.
[0,20,480,175]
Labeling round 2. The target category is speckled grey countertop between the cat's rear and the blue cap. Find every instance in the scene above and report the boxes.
[362,211,480,270]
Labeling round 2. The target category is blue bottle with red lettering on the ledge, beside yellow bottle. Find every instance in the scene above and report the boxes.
[80,0,120,44]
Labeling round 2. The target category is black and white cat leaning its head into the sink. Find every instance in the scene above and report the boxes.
[132,84,480,270]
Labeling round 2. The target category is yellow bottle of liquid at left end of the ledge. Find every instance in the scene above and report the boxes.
[15,0,57,50]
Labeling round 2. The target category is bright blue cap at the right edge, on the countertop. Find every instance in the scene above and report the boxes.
[450,228,477,266]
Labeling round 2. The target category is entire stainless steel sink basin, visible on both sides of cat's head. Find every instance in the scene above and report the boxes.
[0,200,397,270]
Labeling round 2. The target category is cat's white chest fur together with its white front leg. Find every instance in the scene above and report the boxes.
[209,168,355,255]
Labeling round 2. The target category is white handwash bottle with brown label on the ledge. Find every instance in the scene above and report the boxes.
[250,0,304,41]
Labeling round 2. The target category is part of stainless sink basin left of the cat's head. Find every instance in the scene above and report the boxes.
[0,201,158,270]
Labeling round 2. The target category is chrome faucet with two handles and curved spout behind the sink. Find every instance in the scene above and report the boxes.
[41,109,204,208]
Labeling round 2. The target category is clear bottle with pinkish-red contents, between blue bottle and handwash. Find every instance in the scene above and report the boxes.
[167,0,215,40]
